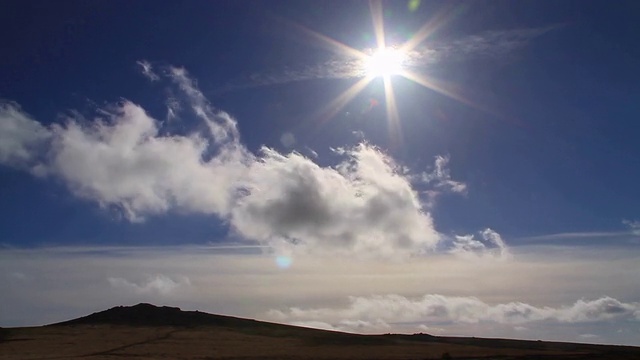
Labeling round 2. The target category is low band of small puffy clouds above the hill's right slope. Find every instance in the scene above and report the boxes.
[268,294,640,331]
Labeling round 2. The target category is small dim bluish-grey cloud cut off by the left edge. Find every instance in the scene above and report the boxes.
[0,102,49,169]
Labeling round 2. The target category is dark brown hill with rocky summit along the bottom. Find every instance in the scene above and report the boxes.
[0,304,640,360]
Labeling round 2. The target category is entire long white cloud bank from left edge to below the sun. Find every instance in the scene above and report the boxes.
[0,63,464,258]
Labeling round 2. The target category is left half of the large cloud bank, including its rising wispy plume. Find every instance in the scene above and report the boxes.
[0,66,252,221]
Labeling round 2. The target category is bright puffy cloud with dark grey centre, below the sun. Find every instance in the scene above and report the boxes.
[232,144,439,257]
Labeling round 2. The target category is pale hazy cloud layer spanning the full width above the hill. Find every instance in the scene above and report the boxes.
[0,246,640,345]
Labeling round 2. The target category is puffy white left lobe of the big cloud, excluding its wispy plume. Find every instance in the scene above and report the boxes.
[49,102,248,221]
